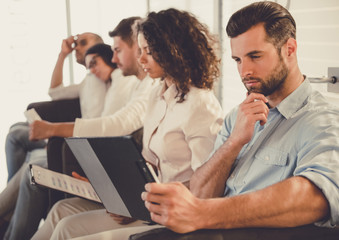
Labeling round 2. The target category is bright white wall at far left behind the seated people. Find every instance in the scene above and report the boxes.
[0,0,66,190]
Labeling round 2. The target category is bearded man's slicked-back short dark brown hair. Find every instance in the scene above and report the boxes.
[226,1,296,49]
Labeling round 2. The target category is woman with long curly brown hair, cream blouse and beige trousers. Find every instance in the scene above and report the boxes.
[31,9,223,240]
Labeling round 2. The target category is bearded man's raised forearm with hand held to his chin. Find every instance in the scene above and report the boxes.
[190,93,269,198]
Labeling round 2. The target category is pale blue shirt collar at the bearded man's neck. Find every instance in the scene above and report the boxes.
[277,78,312,119]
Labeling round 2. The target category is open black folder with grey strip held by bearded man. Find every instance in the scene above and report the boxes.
[65,136,157,222]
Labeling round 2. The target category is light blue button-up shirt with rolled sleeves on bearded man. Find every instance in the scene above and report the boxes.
[212,79,339,227]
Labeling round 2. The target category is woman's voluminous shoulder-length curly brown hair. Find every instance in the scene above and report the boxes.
[138,8,220,102]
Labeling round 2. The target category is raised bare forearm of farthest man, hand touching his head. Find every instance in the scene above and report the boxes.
[50,36,74,88]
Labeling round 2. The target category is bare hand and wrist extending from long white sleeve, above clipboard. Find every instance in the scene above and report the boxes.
[29,120,74,140]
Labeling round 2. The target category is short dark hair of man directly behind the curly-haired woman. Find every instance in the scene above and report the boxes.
[108,17,141,47]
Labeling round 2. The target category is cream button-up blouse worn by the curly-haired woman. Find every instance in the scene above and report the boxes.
[142,83,223,186]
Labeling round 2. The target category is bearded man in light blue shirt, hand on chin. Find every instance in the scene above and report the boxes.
[142,1,339,233]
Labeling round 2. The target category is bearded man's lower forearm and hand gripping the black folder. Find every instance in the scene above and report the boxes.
[142,177,329,233]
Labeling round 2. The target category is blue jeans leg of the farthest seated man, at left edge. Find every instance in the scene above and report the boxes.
[5,122,46,181]
